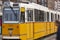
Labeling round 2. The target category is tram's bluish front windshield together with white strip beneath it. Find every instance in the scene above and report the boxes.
[3,7,19,23]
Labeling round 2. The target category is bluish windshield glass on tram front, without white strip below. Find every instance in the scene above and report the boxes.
[3,8,19,21]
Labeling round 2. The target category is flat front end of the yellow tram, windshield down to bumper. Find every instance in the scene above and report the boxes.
[2,4,20,40]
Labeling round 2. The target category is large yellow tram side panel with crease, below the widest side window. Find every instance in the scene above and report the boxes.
[34,22,46,38]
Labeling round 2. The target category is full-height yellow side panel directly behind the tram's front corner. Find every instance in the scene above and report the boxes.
[19,23,28,40]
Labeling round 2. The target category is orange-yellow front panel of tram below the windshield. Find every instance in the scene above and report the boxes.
[2,24,19,36]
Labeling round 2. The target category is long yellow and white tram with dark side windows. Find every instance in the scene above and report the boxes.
[2,3,60,40]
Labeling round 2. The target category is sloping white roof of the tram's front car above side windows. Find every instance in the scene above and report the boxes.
[19,3,49,12]
